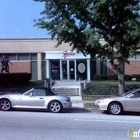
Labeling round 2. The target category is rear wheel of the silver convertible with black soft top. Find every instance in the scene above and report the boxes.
[49,101,62,113]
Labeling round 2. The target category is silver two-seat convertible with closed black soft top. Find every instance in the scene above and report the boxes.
[0,87,72,113]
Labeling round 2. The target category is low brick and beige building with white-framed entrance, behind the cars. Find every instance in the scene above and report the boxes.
[0,38,140,81]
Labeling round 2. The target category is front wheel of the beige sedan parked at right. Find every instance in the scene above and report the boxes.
[108,102,122,115]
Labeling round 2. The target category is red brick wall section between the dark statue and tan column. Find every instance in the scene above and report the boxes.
[5,62,30,73]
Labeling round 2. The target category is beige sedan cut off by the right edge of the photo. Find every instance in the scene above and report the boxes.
[93,89,140,115]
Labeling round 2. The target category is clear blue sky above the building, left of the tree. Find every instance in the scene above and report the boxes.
[0,0,50,38]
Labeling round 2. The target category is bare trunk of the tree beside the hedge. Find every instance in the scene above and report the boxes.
[118,59,125,94]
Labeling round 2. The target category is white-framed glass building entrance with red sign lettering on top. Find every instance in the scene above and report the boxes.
[45,51,90,81]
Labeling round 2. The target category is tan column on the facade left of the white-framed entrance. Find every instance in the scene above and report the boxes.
[37,53,42,80]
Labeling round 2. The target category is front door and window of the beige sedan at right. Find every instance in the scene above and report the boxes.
[124,91,140,111]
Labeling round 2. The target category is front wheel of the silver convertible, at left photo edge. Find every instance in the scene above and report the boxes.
[0,99,11,111]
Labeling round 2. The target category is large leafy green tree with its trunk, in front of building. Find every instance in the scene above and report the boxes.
[34,0,140,94]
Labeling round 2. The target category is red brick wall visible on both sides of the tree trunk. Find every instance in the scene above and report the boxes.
[108,60,140,75]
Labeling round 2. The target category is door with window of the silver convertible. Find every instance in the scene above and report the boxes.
[21,89,46,108]
